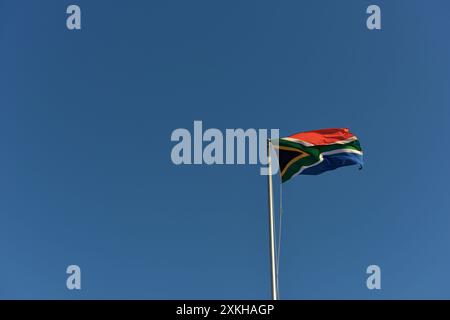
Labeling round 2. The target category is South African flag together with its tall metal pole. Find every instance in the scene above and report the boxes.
[267,128,363,300]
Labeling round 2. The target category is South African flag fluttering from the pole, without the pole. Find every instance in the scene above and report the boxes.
[272,128,363,182]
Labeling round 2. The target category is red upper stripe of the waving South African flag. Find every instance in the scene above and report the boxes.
[289,128,354,145]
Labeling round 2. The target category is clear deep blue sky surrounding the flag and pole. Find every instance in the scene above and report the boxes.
[0,0,450,299]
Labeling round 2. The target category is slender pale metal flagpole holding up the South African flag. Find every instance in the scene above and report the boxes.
[267,139,278,300]
